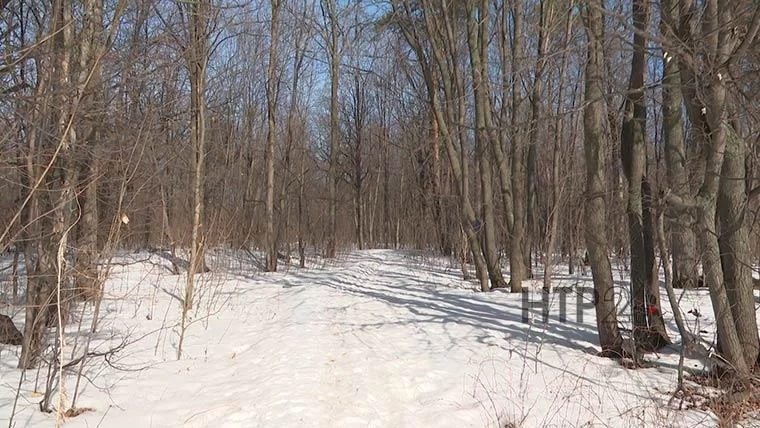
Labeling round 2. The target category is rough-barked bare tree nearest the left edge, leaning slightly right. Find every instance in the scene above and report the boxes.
[19,1,73,369]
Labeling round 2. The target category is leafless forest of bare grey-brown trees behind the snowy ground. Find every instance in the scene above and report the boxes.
[0,0,760,418]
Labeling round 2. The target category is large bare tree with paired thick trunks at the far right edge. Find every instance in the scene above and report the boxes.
[663,0,760,377]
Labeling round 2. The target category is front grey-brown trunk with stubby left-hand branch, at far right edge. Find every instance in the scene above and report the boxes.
[663,0,757,377]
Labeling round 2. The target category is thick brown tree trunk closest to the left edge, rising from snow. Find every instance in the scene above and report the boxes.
[19,0,76,369]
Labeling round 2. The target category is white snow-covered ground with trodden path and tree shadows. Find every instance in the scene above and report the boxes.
[0,250,752,428]
